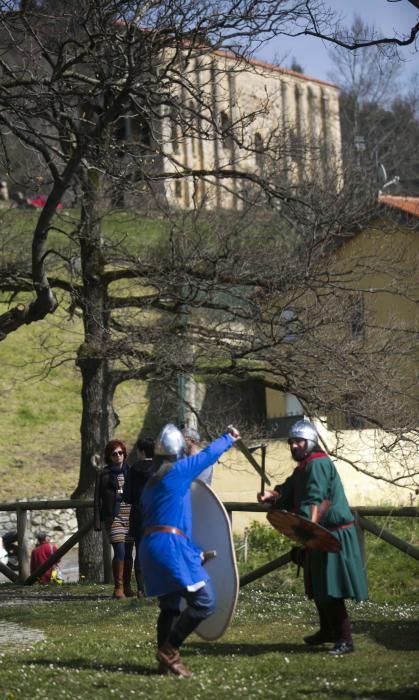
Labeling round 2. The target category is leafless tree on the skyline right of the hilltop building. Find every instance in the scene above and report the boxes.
[330,17,419,195]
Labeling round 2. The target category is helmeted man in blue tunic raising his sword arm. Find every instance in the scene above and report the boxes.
[140,423,240,677]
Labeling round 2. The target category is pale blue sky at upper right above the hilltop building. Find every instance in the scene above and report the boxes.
[257,0,419,88]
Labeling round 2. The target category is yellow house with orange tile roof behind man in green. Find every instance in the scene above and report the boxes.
[182,195,419,531]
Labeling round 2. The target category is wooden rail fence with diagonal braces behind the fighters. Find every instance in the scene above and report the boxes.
[0,499,419,587]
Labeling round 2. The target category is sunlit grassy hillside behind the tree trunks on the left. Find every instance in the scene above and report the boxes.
[0,210,170,502]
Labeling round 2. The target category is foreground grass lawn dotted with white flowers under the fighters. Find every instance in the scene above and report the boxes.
[0,575,419,700]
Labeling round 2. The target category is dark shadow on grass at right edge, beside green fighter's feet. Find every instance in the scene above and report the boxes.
[354,620,419,651]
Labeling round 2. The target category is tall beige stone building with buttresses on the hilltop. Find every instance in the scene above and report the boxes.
[162,51,341,209]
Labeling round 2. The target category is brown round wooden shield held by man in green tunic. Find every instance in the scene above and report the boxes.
[266,510,341,552]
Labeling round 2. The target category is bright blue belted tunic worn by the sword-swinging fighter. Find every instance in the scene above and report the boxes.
[140,434,234,596]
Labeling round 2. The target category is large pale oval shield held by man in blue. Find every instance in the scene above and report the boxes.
[186,479,239,641]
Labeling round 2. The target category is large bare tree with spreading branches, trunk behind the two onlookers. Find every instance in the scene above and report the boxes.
[0,0,418,579]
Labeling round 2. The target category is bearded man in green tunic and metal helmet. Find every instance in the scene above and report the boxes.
[258,420,368,656]
